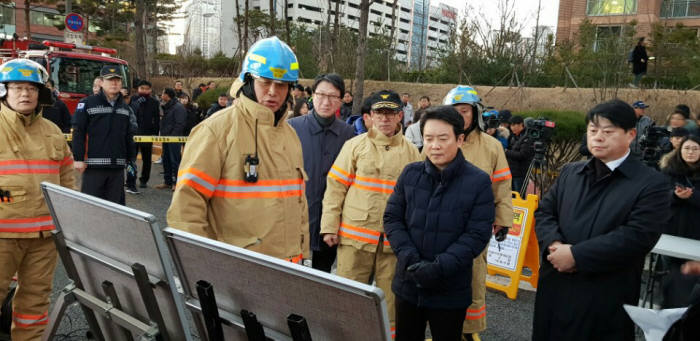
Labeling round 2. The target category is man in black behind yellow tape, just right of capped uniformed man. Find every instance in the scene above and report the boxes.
[126,80,160,194]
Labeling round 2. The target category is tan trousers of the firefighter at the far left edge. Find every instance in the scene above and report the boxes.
[0,237,57,341]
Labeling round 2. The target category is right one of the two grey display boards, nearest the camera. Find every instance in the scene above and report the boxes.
[164,228,391,341]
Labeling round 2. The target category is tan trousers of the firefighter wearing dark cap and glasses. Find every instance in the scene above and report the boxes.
[336,245,396,334]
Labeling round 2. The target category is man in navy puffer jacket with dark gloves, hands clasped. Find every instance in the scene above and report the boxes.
[384,106,495,340]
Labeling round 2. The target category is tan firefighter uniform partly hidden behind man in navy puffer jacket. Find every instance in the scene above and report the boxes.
[462,129,513,334]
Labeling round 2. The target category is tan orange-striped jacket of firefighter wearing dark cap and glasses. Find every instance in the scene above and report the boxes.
[321,128,421,253]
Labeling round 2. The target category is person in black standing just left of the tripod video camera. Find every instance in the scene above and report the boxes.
[506,115,535,192]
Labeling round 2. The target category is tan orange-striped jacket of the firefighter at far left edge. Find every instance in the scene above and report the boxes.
[0,102,75,238]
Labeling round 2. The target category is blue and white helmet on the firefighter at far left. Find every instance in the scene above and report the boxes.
[0,58,53,105]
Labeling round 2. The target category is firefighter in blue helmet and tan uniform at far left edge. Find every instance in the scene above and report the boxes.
[0,59,75,341]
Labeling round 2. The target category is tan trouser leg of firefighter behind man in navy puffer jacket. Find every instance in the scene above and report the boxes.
[462,247,489,334]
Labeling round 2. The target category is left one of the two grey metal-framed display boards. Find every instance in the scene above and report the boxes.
[42,183,192,340]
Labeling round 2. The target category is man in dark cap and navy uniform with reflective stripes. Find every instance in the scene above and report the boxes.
[73,65,137,205]
